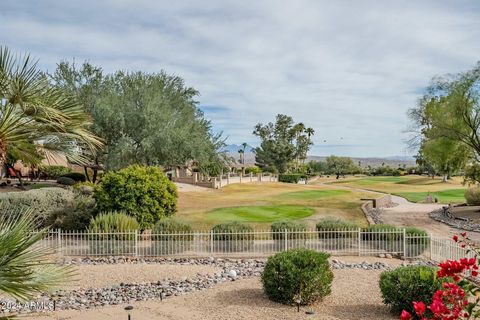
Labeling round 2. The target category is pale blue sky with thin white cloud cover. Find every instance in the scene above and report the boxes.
[0,0,480,157]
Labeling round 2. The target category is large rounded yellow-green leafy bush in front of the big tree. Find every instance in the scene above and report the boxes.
[94,165,177,229]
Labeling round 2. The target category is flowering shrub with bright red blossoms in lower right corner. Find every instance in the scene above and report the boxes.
[400,232,480,320]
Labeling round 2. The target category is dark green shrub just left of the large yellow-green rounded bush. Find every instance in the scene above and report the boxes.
[47,194,95,230]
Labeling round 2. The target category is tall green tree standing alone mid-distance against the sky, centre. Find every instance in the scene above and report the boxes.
[253,114,313,173]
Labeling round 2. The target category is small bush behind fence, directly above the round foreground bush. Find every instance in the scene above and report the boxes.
[271,221,307,250]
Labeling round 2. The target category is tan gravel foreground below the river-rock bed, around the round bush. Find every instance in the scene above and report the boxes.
[21,270,398,320]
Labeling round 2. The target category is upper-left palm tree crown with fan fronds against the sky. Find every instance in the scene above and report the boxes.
[0,47,102,174]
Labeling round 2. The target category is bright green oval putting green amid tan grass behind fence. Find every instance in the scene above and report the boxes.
[207,205,315,222]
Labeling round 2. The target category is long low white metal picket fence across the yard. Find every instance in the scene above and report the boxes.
[39,229,469,260]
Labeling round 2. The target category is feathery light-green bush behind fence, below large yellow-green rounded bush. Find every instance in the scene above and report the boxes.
[88,211,139,255]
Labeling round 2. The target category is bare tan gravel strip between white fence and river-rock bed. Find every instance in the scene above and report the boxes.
[65,264,222,290]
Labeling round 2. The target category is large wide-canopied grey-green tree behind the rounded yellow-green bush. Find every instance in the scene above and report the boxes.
[51,62,228,174]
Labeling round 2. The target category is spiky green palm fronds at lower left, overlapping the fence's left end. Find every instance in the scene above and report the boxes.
[0,208,72,301]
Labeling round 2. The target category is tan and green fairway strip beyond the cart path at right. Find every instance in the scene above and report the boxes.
[320,175,466,203]
